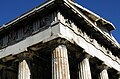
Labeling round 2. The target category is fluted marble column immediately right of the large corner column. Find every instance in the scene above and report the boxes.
[78,56,91,79]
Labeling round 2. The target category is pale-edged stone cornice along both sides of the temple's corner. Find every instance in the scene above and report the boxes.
[0,0,120,54]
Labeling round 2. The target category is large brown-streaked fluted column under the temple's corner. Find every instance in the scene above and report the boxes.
[52,45,70,79]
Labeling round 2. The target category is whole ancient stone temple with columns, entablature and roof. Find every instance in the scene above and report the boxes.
[0,0,120,79]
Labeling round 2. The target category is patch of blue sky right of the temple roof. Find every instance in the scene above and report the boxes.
[76,0,120,43]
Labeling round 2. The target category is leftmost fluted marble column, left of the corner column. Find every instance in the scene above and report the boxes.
[18,55,31,79]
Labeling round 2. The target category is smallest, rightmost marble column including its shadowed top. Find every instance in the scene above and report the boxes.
[99,64,109,79]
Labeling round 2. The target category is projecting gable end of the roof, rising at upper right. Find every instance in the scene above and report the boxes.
[70,1,115,31]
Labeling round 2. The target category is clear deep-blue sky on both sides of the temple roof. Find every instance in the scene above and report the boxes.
[0,0,120,43]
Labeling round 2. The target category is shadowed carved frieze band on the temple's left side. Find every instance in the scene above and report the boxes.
[0,13,55,49]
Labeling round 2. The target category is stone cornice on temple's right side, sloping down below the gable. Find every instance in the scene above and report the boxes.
[56,0,120,55]
